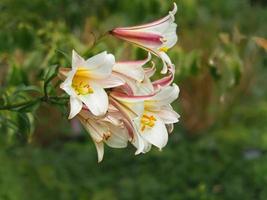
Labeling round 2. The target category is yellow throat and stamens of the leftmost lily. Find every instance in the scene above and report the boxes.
[72,68,94,95]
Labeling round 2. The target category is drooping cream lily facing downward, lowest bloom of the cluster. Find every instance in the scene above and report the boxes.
[78,106,129,162]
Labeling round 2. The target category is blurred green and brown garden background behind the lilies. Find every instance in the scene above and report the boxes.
[0,0,267,200]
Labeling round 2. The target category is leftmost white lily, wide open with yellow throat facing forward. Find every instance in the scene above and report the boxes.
[59,50,124,119]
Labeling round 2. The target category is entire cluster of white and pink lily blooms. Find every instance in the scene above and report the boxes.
[59,4,179,162]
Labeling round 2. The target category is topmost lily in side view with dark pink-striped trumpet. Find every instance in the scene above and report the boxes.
[110,3,177,74]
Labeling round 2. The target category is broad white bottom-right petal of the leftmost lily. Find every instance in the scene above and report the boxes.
[79,83,108,116]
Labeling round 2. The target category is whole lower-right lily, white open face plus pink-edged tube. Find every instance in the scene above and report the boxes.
[110,84,179,154]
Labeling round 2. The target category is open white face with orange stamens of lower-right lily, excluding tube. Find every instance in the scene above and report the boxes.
[134,84,179,152]
